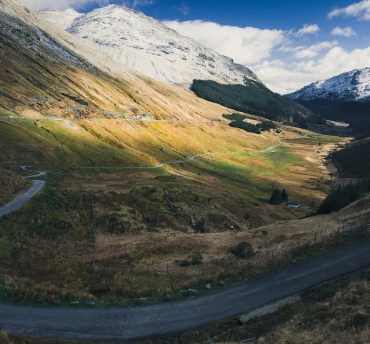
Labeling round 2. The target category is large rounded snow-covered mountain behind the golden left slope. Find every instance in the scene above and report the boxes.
[38,5,259,86]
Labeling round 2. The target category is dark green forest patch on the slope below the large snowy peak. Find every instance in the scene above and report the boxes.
[192,80,322,128]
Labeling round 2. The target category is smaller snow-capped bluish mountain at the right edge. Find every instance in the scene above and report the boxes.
[287,68,370,102]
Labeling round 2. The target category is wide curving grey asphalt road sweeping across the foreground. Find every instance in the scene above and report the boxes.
[0,240,370,342]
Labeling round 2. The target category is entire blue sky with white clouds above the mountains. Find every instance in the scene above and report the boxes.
[20,0,370,94]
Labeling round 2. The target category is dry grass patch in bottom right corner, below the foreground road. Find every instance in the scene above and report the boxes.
[257,282,370,344]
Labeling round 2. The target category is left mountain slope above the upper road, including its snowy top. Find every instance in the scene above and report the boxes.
[0,0,243,120]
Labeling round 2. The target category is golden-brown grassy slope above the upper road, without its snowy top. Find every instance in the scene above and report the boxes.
[0,16,237,120]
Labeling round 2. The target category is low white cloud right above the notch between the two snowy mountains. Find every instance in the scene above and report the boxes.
[252,47,370,93]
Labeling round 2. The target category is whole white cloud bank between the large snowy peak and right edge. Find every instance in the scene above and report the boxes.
[164,18,370,94]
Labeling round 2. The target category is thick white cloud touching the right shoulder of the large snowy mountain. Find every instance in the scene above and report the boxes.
[163,20,285,64]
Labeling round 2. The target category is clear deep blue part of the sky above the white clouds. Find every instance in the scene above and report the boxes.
[79,0,370,47]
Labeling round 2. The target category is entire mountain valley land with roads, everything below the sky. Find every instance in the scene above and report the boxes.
[0,0,370,344]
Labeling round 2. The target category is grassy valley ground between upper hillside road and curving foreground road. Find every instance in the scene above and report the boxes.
[0,112,343,303]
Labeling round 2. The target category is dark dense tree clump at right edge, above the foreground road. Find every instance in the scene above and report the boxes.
[318,179,370,214]
